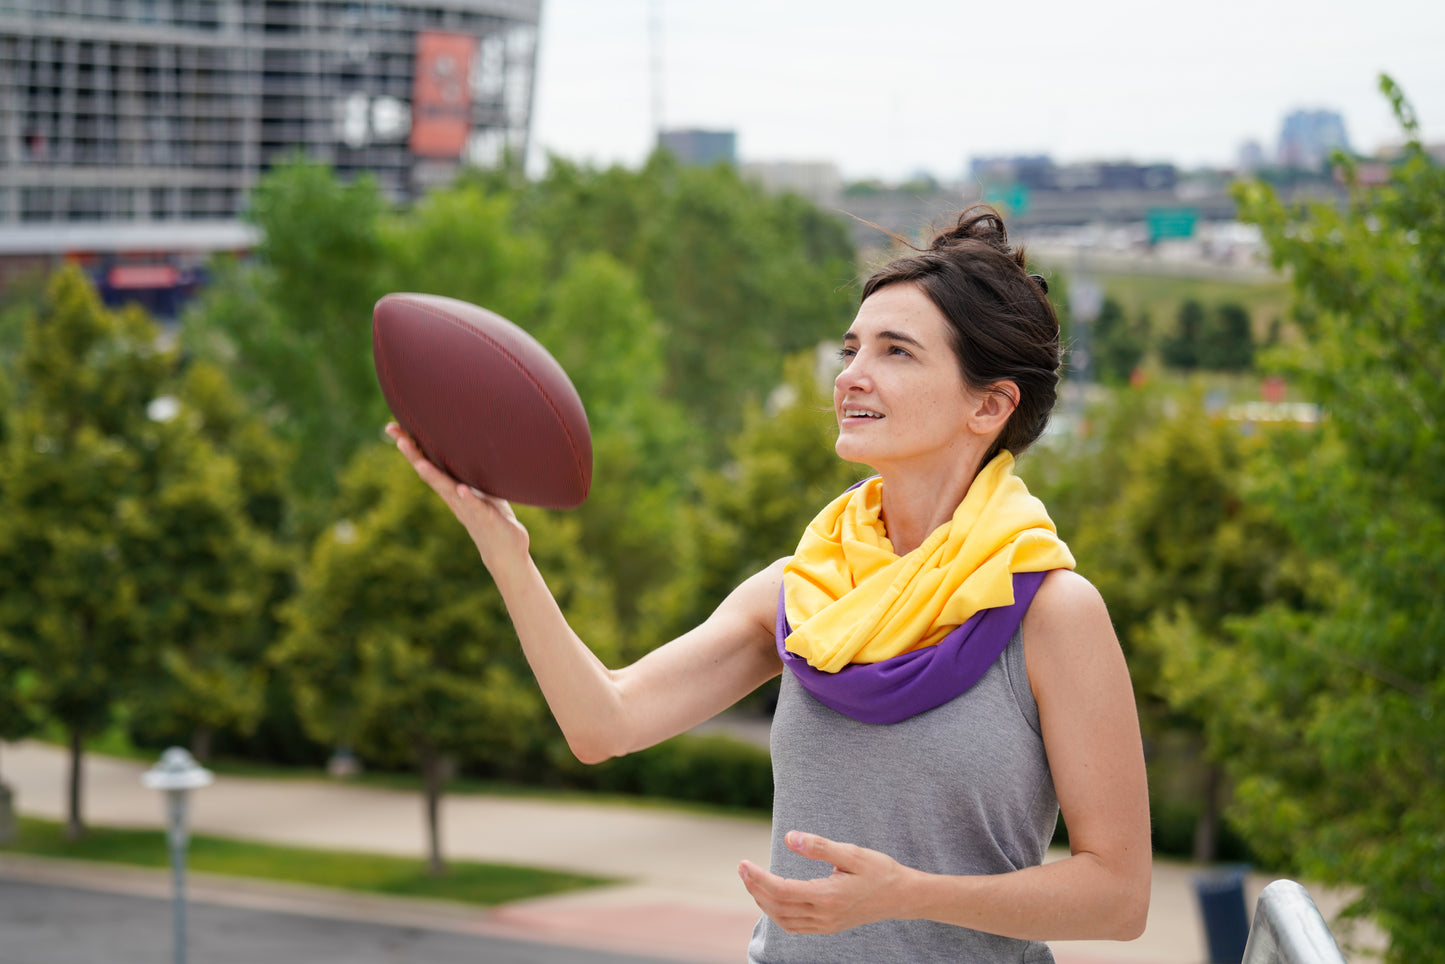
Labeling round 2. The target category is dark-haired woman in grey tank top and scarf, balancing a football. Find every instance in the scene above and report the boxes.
[387,208,1150,964]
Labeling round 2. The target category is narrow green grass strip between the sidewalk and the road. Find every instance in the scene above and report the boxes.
[0,817,613,906]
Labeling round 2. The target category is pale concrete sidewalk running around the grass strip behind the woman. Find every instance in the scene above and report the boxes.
[0,743,1332,964]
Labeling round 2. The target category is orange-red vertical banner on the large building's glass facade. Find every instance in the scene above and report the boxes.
[409,32,477,158]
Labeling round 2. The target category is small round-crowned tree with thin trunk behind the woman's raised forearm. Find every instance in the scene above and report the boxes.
[272,445,614,873]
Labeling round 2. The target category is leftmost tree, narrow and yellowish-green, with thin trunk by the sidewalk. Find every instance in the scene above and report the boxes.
[0,267,173,837]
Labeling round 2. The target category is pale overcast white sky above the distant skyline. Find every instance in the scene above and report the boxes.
[529,0,1445,182]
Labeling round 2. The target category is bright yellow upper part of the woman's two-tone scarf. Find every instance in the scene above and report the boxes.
[783,451,1074,672]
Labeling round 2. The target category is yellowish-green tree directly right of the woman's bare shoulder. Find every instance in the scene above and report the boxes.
[1040,392,1308,860]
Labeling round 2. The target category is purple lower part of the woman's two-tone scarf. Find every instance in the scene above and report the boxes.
[777,572,1048,723]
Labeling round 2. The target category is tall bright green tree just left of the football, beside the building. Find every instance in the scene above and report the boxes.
[185,159,395,516]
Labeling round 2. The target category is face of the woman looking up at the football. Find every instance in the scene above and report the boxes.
[832,283,980,471]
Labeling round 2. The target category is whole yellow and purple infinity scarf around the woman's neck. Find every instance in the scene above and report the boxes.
[777,451,1074,721]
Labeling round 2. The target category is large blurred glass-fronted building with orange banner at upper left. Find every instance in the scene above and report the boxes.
[0,0,540,313]
